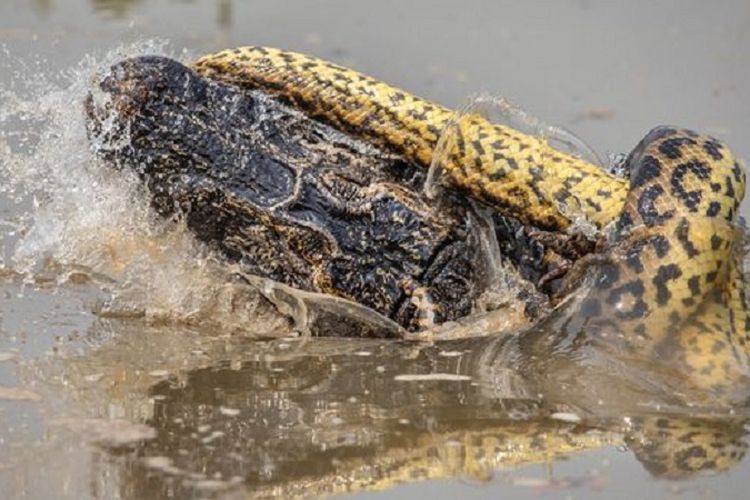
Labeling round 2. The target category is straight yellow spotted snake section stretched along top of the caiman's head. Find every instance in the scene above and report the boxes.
[194,47,628,230]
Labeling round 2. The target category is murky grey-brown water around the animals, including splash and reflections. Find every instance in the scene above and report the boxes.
[0,0,750,498]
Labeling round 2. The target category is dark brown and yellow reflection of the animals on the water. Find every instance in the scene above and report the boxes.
[45,324,747,498]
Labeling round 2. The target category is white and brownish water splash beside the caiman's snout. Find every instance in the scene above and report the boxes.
[0,40,300,335]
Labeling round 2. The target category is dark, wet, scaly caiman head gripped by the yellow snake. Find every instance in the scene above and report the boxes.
[87,57,546,336]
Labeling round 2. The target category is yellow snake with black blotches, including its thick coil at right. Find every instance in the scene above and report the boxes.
[193,47,750,394]
